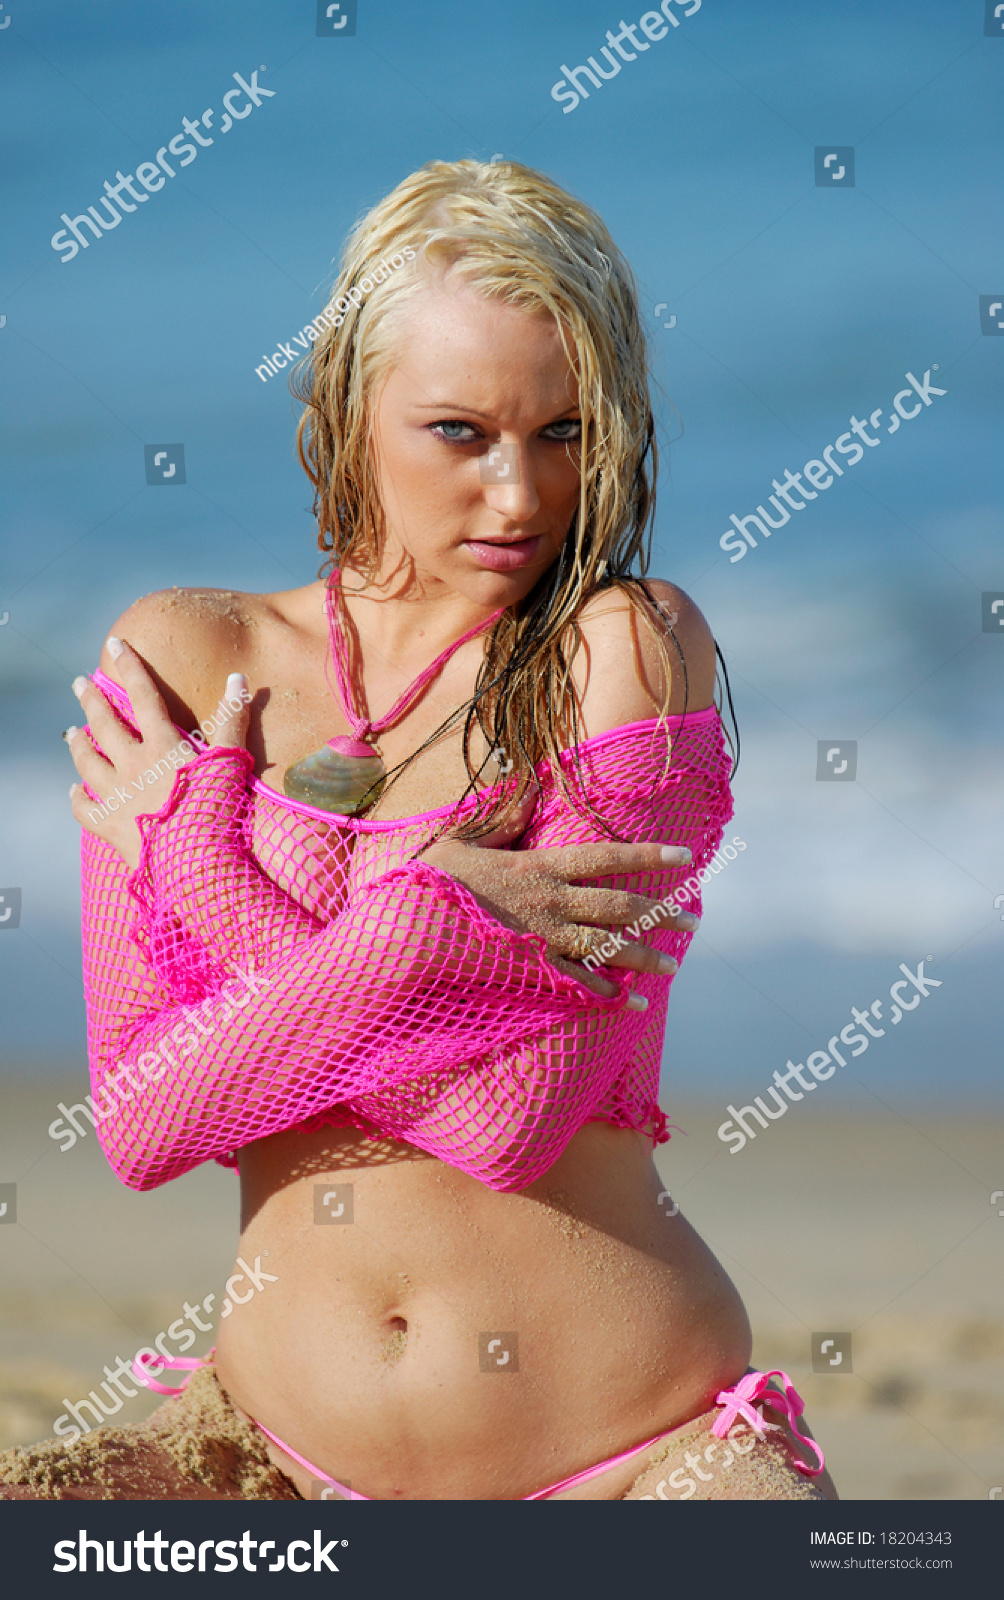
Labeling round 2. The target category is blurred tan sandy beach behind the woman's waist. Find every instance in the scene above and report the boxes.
[0,1078,1004,1501]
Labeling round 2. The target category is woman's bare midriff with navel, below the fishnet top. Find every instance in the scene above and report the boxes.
[217,1123,750,1499]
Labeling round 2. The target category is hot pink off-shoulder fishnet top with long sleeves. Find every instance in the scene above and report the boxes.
[83,672,732,1190]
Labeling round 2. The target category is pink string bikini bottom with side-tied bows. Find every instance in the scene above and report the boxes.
[133,1355,825,1499]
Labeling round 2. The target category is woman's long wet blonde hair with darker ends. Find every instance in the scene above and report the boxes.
[293,160,679,837]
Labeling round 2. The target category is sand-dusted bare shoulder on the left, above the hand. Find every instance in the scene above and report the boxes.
[101,589,273,722]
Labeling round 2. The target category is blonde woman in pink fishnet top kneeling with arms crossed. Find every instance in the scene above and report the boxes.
[0,162,833,1499]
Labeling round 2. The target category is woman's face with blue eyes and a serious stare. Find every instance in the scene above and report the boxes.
[373,280,582,610]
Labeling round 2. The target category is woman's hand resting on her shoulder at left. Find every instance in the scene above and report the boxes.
[64,638,249,867]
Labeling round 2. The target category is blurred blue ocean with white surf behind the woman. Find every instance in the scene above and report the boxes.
[0,0,1004,1099]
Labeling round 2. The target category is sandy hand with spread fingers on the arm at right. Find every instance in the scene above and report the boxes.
[422,829,700,1000]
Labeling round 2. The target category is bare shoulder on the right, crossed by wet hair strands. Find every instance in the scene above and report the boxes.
[574,578,716,734]
